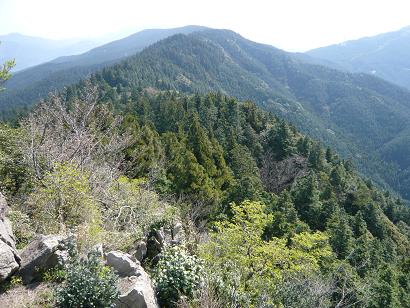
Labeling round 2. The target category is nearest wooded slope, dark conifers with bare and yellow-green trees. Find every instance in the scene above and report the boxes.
[0,83,410,307]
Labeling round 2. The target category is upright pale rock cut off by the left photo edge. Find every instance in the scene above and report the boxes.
[0,193,21,282]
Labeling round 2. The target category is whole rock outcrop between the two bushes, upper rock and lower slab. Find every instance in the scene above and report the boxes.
[106,251,158,308]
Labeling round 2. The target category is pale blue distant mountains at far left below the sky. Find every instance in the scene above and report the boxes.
[0,33,98,71]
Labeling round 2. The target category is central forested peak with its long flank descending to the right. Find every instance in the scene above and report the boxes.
[90,30,410,198]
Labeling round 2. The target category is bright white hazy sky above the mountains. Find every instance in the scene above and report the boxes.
[0,0,410,51]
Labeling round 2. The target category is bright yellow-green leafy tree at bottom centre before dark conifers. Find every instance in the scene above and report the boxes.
[201,201,332,306]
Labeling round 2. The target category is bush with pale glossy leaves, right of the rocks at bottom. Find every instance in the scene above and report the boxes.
[154,246,203,307]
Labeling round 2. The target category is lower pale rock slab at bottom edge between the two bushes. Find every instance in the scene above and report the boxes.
[115,268,159,308]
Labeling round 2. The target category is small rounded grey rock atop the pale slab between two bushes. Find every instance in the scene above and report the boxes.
[105,251,142,277]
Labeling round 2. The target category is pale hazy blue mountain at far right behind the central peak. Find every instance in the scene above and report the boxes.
[306,27,410,89]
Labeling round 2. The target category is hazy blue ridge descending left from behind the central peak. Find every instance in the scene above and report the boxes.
[0,26,205,119]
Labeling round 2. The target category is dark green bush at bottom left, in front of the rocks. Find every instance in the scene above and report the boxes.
[55,254,119,308]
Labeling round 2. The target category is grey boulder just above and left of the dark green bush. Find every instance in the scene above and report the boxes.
[19,235,68,284]
